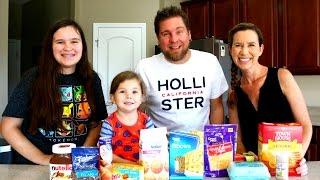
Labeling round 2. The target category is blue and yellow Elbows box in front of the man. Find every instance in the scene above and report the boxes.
[169,131,203,179]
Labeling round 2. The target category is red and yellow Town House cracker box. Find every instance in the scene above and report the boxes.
[258,122,302,176]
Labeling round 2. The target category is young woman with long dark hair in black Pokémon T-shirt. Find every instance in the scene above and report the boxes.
[1,19,107,165]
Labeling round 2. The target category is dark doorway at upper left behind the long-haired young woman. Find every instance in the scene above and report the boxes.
[8,0,74,96]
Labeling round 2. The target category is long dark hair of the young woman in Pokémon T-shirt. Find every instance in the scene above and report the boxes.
[28,19,95,133]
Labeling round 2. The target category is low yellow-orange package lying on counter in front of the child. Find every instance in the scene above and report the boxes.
[112,163,144,180]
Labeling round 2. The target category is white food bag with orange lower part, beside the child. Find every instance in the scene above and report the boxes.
[139,127,169,180]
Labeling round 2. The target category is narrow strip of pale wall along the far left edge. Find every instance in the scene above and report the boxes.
[0,0,9,114]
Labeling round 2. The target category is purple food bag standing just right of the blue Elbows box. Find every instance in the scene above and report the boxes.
[204,124,237,177]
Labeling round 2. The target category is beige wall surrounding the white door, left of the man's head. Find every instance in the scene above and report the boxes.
[75,0,159,60]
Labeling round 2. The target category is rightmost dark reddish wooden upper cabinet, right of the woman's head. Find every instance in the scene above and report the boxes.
[279,0,320,74]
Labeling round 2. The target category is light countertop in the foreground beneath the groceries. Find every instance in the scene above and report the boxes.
[0,161,320,180]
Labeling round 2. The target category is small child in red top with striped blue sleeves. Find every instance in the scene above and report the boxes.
[100,71,154,163]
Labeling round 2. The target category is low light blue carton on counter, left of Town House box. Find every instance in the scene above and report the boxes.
[227,161,270,180]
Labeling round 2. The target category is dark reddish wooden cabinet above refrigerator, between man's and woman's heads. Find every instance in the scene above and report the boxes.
[181,0,239,41]
